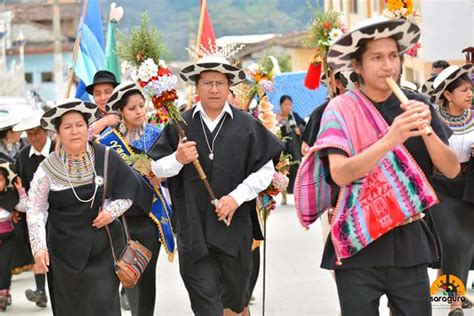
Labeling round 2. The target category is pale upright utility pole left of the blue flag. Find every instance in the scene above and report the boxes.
[52,0,64,99]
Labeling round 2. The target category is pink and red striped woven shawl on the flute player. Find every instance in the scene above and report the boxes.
[295,90,438,260]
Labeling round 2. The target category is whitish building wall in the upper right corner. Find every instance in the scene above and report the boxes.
[420,0,474,62]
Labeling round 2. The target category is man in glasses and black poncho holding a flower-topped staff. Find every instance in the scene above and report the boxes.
[149,56,283,316]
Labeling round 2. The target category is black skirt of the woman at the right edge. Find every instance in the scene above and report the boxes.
[431,174,474,283]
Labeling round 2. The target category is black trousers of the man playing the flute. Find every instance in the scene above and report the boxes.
[335,265,431,316]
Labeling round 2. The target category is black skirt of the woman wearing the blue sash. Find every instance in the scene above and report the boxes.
[127,215,161,316]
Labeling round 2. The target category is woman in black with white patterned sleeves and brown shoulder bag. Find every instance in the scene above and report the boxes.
[27,99,142,316]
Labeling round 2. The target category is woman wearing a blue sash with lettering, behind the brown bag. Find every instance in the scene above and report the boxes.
[98,81,170,316]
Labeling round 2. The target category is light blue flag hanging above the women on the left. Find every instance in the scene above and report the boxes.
[74,0,105,100]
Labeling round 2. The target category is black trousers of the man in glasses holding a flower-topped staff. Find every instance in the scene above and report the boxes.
[178,236,252,316]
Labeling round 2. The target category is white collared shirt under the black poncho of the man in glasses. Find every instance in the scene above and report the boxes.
[151,102,275,206]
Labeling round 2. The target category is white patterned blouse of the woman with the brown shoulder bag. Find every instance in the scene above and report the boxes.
[26,164,133,255]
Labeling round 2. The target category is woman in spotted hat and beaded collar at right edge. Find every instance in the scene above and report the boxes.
[430,65,474,316]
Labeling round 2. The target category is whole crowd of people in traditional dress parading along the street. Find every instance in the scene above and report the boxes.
[0,12,474,316]
